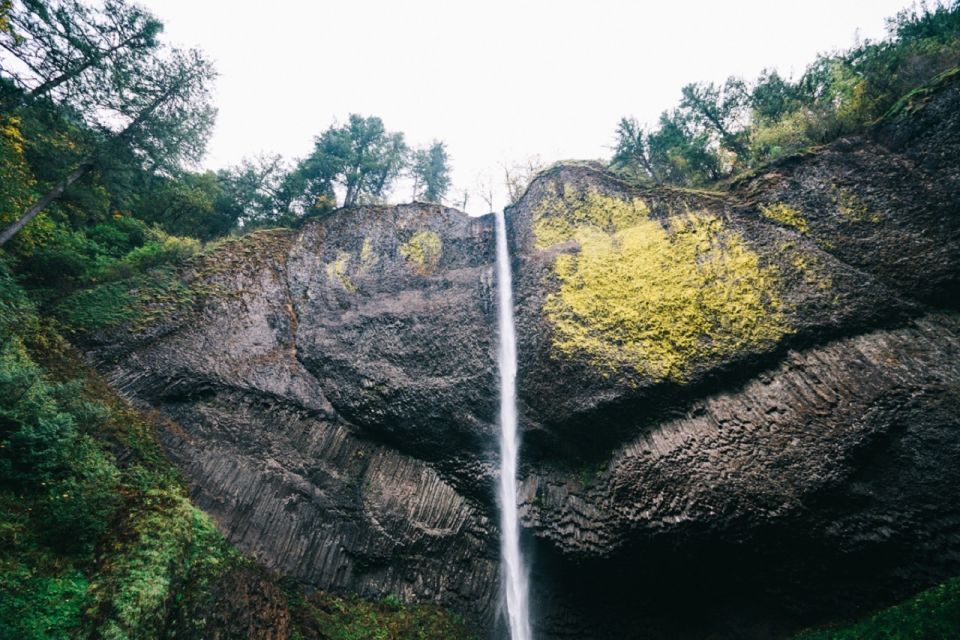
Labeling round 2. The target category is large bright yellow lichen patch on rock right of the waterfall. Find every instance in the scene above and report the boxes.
[544,213,791,381]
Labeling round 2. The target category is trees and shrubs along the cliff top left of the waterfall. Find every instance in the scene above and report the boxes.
[0,0,449,342]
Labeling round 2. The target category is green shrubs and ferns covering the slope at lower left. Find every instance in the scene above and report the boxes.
[0,276,255,640]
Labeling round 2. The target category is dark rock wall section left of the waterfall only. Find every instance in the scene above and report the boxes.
[90,205,498,620]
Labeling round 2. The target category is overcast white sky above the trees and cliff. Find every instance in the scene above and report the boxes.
[135,0,909,212]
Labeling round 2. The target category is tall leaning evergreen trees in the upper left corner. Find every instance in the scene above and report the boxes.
[0,0,218,250]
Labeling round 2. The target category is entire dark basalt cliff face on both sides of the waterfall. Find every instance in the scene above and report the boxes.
[84,74,960,638]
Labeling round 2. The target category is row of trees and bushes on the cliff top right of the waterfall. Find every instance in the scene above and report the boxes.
[611,0,960,185]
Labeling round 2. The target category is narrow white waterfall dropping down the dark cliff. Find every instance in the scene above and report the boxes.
[496,212,531,640]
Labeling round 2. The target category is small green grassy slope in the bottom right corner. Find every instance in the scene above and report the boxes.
[795,578,960,640]
